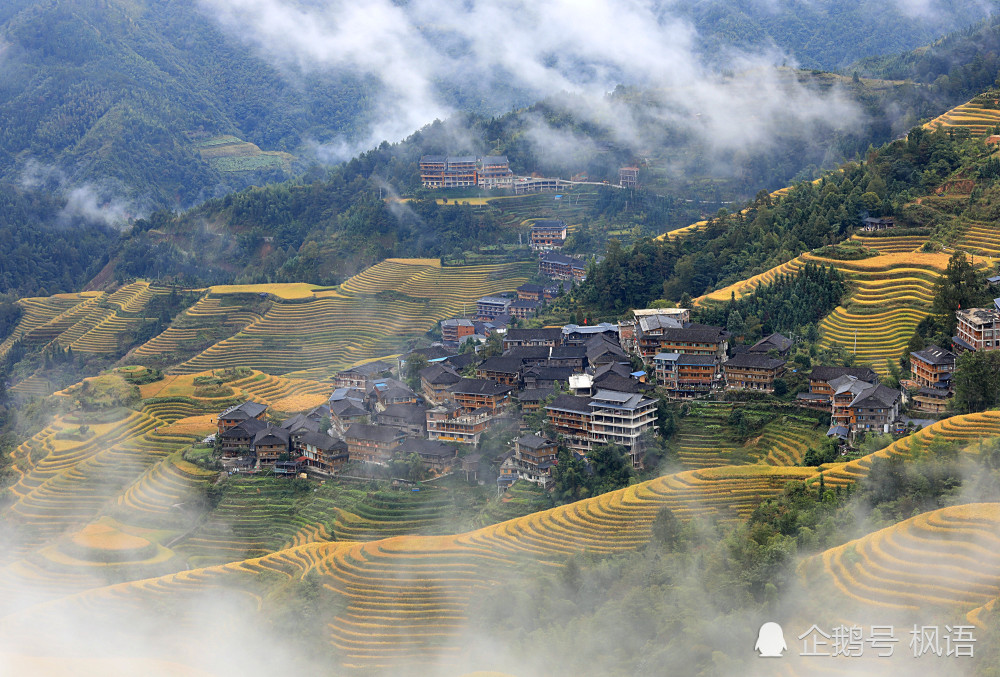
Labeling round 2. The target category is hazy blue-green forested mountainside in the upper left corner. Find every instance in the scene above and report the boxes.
[0,0,373,207]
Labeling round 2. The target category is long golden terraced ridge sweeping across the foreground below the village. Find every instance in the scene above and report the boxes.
[4,466,812,669]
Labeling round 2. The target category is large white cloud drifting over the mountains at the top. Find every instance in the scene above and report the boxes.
[201,0,864,159]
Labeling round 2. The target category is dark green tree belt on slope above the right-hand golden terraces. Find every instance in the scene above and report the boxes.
[575,128,985,313]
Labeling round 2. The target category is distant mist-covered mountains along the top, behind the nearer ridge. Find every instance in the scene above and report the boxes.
[0,0,1000,213]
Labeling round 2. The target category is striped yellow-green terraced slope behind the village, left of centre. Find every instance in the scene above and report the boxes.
[174,259,533,377]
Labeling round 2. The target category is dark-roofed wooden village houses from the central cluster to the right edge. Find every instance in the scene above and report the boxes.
[217,296,1000,487]
